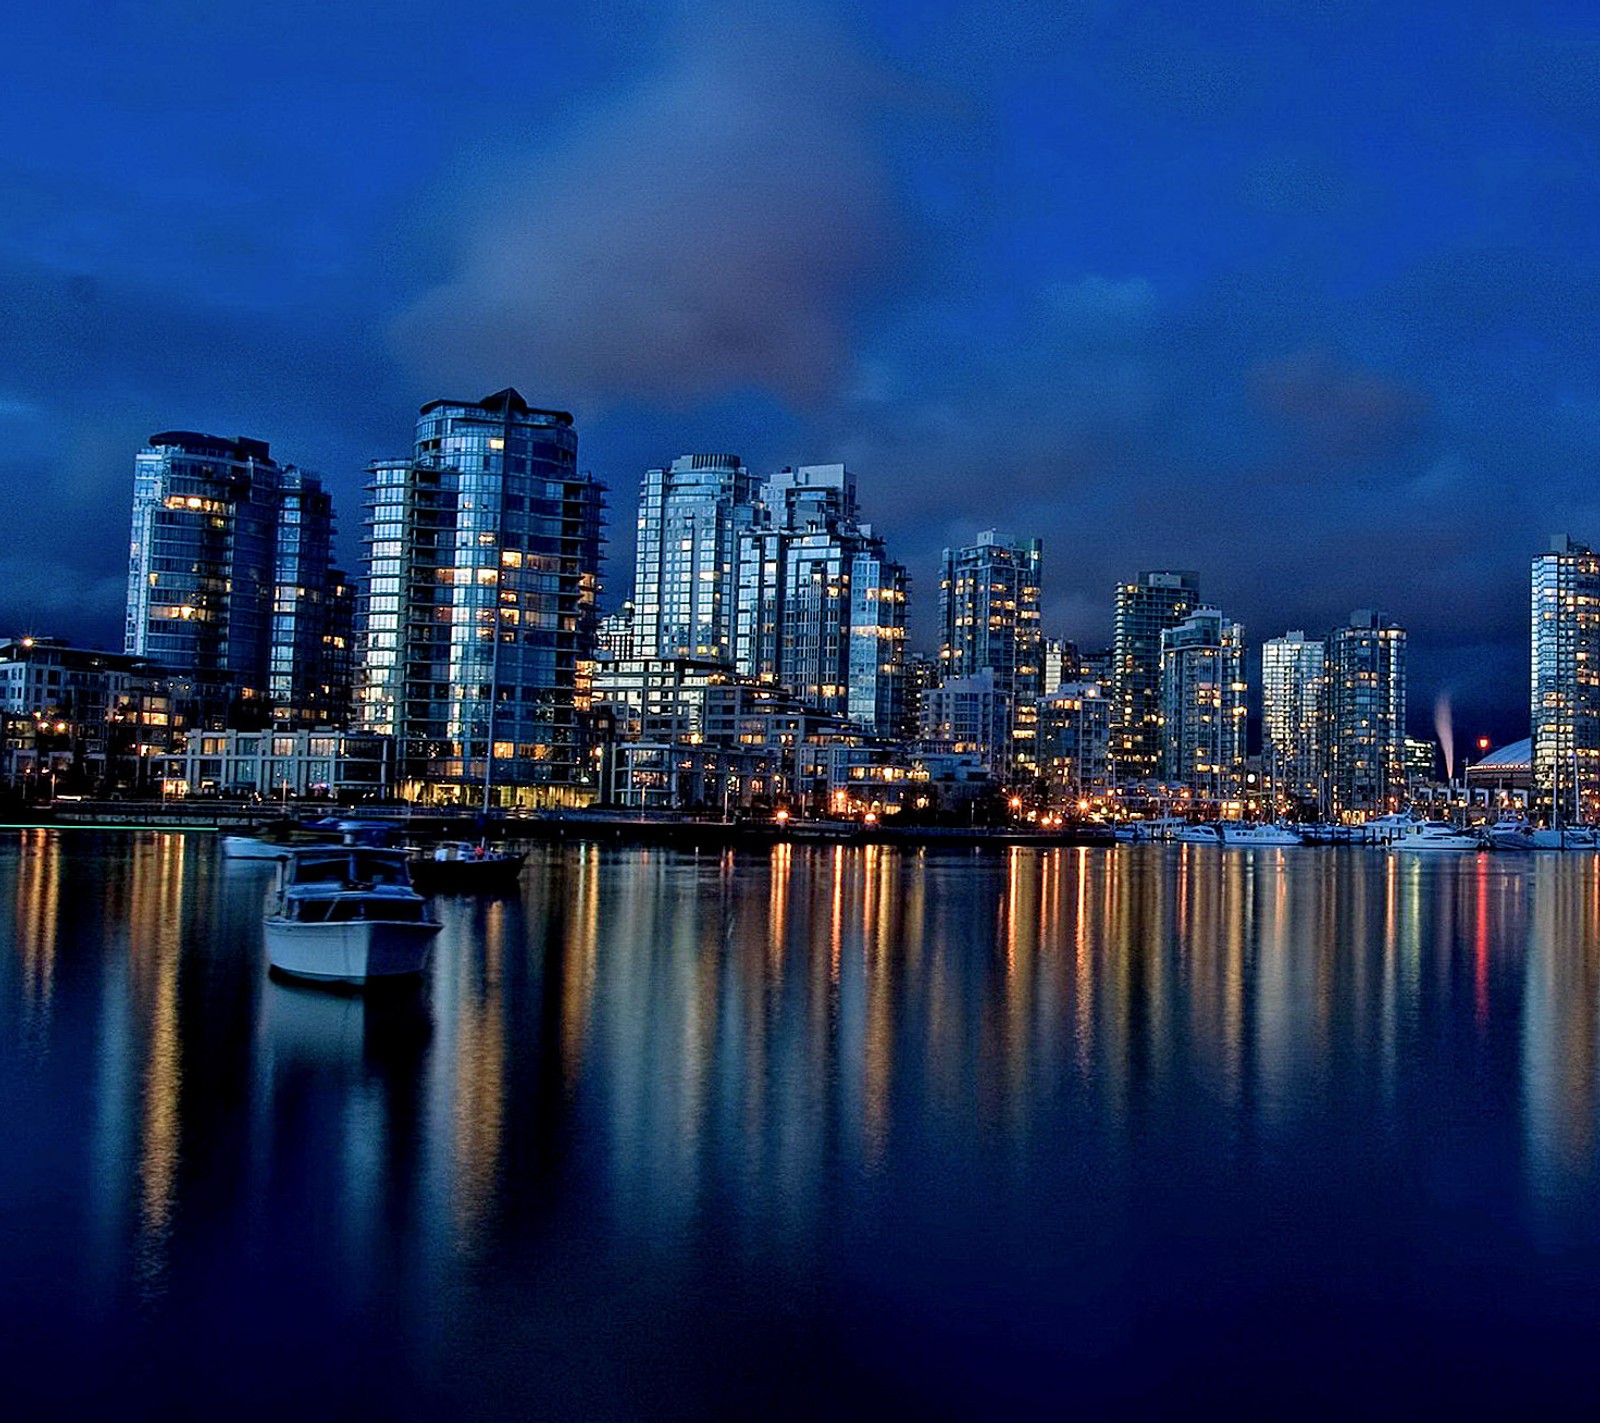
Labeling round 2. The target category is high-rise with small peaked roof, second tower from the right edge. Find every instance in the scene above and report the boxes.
[1325,608,1406,816]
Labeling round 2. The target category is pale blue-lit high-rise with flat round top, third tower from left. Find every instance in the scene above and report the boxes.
[634,455,755,661]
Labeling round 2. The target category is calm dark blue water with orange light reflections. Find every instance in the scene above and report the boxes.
[0,832,1600,1423]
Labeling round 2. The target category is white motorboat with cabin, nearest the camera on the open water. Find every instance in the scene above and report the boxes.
[266,845,440,984]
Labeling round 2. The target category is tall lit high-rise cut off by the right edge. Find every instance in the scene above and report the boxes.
[1528,535,1600,824]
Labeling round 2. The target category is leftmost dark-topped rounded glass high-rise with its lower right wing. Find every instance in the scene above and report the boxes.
[123,431,349,725]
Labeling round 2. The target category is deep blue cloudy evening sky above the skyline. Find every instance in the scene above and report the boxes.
[0,0,1600,736]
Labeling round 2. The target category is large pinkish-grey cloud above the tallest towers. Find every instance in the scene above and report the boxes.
[392,6,894,408]
